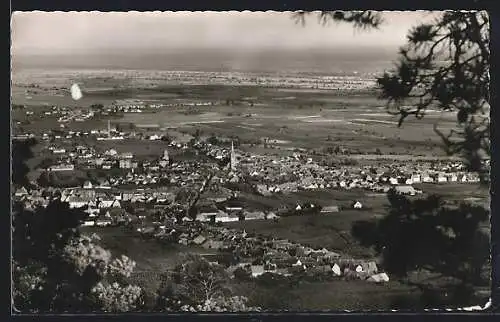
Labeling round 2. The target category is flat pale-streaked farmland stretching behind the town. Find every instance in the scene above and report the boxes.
[12,69,456,155]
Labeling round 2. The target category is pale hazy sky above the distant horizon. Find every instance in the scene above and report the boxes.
[11,11,437,54]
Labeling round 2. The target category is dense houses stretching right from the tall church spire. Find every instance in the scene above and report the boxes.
[232,150,480,195]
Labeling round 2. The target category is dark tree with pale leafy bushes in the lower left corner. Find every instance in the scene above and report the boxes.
[12,201,142,313]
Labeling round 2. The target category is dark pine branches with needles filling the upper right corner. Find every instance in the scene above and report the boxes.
[378,11,490,171]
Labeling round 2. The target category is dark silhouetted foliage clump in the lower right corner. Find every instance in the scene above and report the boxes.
[352,190,489,305]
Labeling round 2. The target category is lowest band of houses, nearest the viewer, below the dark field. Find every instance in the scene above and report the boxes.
[138,219,389,282]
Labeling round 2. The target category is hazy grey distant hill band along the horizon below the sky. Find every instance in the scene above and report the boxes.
[12,49,396,73]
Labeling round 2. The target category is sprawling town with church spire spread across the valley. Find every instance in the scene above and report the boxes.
[14,102,488,290]
